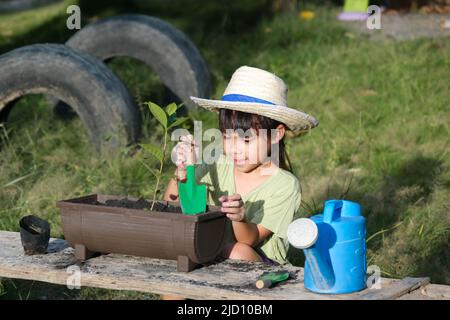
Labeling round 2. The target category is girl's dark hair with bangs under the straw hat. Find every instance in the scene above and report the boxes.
[219,109,293,173]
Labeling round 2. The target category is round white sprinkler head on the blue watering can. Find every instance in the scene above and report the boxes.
[287,218,319,249]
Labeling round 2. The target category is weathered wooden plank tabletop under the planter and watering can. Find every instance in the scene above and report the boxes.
[0,231,450,300]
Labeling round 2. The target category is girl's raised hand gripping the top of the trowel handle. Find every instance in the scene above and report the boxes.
[173,135,199,181]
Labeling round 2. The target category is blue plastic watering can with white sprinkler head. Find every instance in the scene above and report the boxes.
[288,200,366,293]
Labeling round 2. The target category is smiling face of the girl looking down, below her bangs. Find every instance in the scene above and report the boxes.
[222,129,270,172]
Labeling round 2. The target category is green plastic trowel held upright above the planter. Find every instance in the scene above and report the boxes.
[178,165,206,214]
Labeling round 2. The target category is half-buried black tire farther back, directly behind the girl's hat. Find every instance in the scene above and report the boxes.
[66,15,211,109]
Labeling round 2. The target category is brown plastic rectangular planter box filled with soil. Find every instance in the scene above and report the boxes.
[57,194,227,272]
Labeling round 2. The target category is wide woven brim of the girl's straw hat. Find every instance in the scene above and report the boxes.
[190,97,319,134]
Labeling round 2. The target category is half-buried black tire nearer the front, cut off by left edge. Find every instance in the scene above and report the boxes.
[0,44,139,151]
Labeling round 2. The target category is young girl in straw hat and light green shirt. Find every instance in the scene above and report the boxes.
[164,66,318,264]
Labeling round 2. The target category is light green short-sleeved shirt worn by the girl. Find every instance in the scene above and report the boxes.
[195,154,301,264]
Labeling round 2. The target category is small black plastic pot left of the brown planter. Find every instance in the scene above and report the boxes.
[19,215,50,255]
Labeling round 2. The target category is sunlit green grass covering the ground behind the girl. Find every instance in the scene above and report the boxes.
[0,4,450,299]
